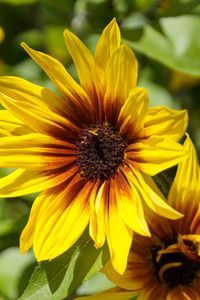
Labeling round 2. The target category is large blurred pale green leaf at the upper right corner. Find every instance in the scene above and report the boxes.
[122,16,200,76]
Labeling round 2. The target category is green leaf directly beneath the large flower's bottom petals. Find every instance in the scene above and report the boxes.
[20,232,109,300]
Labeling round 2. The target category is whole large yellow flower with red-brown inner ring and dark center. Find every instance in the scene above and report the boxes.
[0,19,187,273]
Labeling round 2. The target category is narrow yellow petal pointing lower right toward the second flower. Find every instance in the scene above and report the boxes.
[126,166,183,220]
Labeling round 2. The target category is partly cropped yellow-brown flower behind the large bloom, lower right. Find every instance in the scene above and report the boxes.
[86,137,200,300]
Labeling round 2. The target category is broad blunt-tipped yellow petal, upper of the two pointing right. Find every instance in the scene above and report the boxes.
[144,106,188,141]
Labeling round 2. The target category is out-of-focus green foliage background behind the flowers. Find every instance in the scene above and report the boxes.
[0,0,200,300]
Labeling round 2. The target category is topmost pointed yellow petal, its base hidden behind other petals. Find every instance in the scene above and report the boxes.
[95,18,121,69]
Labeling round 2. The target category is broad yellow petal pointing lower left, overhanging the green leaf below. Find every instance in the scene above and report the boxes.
[33,174,93,261]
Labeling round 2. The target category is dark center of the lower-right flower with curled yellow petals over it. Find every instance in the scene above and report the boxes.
[151,240,200,288]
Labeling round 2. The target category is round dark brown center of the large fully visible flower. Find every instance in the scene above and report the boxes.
[76,123,127,181]
